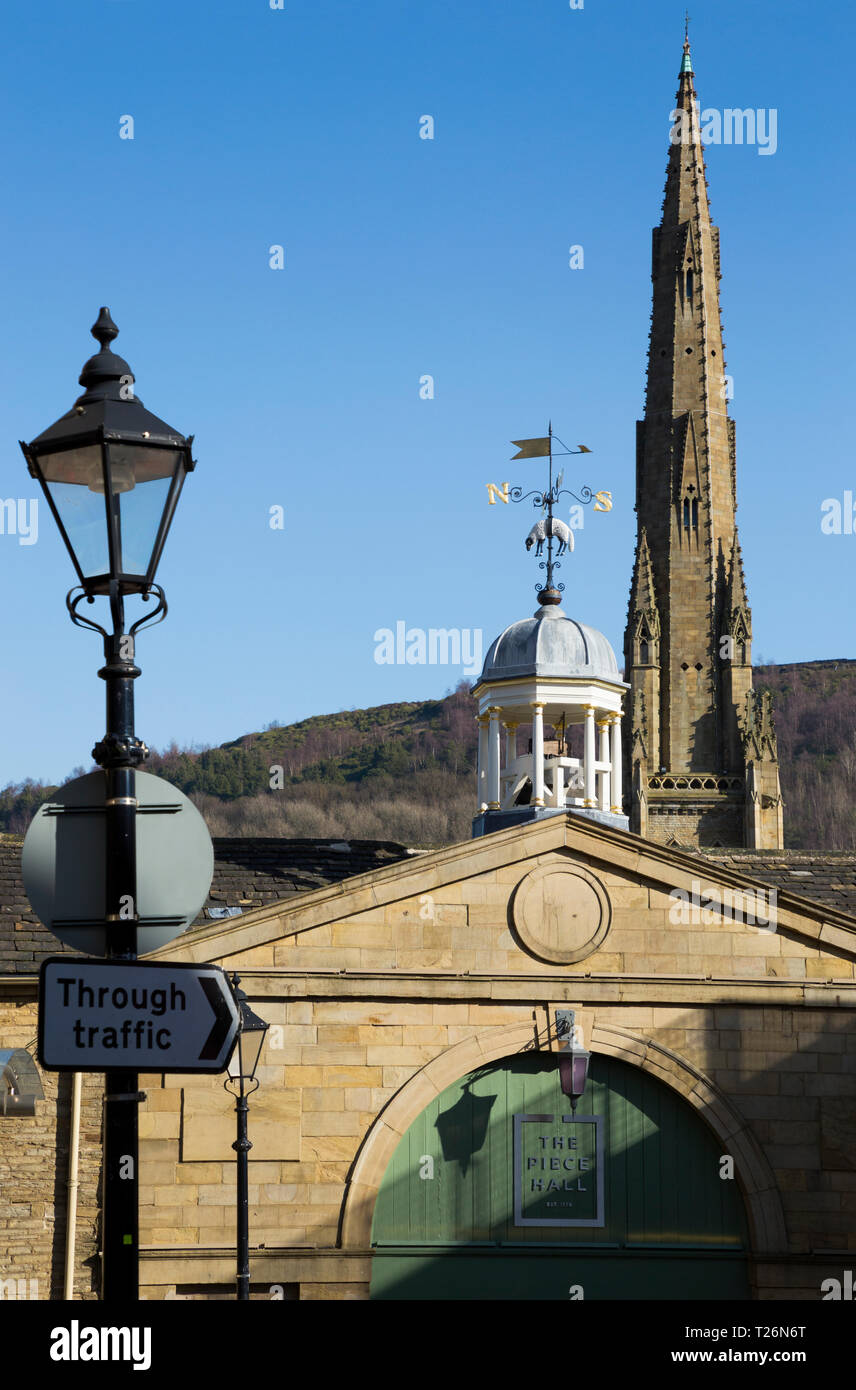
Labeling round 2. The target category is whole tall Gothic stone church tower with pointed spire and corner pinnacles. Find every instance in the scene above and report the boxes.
[624,40,782,849]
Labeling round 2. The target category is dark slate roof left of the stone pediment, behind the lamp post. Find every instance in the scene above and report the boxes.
[0,835,414,977]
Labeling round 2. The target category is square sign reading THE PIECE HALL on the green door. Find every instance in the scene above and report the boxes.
[514,1115,603,1226]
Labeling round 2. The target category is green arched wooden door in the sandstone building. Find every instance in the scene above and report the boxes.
[371,1054,749,1298]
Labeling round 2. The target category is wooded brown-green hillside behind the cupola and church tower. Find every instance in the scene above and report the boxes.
[0,660,856,851]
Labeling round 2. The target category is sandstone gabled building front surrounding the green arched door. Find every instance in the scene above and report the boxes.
[115,813,856,1298]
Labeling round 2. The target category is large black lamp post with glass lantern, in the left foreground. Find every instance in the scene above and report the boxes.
[21,309,195,1302]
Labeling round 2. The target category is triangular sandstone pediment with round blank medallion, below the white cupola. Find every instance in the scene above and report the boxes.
[150,813,856,990]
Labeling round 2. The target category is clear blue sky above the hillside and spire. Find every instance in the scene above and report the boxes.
[0,0,856,784]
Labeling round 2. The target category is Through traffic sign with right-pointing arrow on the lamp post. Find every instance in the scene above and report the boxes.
[38,956,239,1073]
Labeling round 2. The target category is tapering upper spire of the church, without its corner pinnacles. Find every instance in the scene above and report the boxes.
[636,32,739,773]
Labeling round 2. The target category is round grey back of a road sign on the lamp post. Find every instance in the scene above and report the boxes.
[21,771,214,955]
